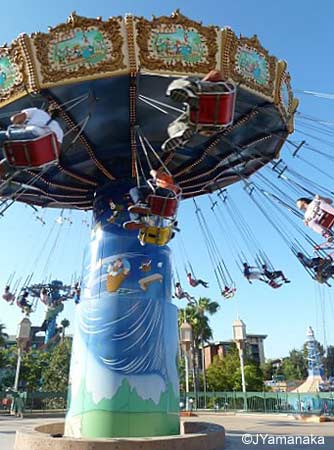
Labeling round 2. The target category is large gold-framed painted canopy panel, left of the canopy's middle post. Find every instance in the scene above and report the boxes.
[32,13,126,85]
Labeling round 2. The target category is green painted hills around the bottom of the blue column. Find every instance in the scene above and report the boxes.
[65,379,180,438]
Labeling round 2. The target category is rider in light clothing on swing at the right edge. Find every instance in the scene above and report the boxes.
[296,195,334,240]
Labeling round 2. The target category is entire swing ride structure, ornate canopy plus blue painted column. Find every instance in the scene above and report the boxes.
[0,11,298,438]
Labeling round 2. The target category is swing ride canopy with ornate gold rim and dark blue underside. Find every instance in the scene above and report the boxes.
[0,11,298,210]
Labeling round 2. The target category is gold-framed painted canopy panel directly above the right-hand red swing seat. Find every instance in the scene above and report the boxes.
[136,11,218,73]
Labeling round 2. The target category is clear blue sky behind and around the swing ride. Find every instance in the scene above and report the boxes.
[0,0,334,358]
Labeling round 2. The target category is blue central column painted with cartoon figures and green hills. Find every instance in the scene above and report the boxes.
[65,185,179,437]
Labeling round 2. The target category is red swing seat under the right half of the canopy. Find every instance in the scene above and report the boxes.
[188,82,236,129]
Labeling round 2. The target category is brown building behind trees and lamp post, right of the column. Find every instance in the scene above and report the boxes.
[204,334,267,369]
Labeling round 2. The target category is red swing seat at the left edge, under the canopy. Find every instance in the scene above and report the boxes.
[3,133,60,169]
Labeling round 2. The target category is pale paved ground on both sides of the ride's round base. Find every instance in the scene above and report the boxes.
[0,414,334,450]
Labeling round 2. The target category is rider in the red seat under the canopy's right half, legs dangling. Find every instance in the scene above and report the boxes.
[161,70,231,152]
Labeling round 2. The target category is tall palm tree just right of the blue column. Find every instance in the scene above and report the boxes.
[179,297,219,400]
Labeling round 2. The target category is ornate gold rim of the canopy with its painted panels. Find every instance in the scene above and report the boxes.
[0,10,298,132]
